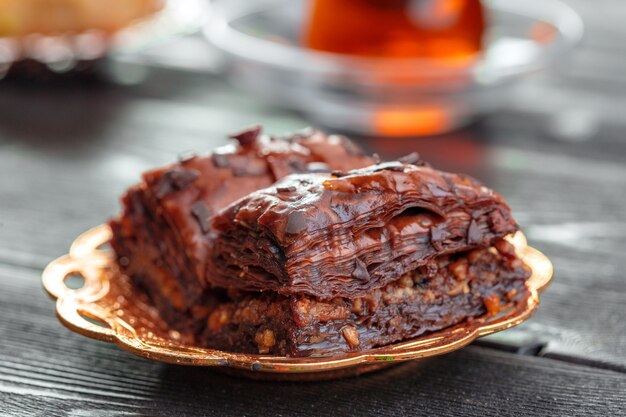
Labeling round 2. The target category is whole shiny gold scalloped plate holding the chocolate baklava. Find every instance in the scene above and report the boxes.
[43,226,552,380]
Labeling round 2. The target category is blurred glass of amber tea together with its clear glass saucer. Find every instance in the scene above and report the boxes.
[204,0,582,136]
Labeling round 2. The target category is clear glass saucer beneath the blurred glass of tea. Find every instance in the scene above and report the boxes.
[204,0,583,136]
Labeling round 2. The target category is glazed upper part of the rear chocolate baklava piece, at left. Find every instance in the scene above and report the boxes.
[110,127,373,310]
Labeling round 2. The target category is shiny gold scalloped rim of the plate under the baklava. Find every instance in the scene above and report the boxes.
[42,225,553,373]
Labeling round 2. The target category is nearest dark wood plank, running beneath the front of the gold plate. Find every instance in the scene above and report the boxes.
[0,264,626,416]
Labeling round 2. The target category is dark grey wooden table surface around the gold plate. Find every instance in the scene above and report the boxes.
[0,0,626,416]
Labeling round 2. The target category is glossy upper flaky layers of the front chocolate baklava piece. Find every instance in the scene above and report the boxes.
[210,162,517,299]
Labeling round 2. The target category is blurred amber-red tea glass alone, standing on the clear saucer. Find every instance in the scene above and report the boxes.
[303,0,486,64]
